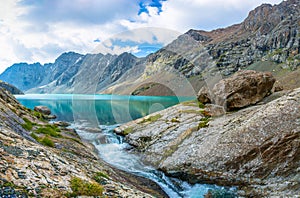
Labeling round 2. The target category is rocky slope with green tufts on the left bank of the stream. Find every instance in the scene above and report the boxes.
[0,89,165,197]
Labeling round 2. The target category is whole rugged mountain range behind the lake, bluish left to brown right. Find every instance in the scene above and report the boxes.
[0,0,300,95]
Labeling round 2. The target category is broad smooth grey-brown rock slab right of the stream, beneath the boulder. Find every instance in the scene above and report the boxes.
[116,88,300,197]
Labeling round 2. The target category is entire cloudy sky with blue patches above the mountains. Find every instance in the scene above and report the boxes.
[0,0,281,73]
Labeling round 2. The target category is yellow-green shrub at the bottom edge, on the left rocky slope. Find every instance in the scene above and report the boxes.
[70,177,103,196]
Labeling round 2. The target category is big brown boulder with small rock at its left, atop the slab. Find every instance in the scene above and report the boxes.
[198,70,275,111]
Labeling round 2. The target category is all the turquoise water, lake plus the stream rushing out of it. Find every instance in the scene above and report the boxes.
[16,94,234,198]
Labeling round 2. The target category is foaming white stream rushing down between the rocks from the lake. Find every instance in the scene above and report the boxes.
[72,122,234,198]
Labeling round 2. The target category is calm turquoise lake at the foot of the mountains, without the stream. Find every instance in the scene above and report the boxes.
[16,94,190,126]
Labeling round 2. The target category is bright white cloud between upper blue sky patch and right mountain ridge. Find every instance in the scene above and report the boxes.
[122,0,281,32]
